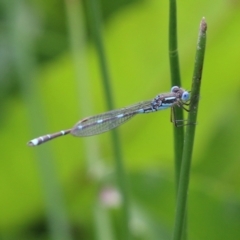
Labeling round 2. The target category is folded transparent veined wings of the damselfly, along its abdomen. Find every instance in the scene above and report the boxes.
[71,100,152,137]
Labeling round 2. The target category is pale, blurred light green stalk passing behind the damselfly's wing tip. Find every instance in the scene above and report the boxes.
[65,0,114,240]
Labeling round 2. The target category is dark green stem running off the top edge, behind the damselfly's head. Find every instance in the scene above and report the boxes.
[169,0,184,189]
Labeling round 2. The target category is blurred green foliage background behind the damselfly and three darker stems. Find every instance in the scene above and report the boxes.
[0,0,240,240]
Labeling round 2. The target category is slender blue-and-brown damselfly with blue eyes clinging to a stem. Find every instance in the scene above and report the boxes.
[28,86,190,146]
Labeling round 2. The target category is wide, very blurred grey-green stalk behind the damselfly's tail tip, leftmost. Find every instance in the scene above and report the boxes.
[8,1,71,240]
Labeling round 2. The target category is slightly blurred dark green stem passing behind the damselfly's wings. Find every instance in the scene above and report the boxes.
[87,0,130,240]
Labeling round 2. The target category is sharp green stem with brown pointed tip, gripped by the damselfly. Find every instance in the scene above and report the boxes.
[173,18,207,240]
